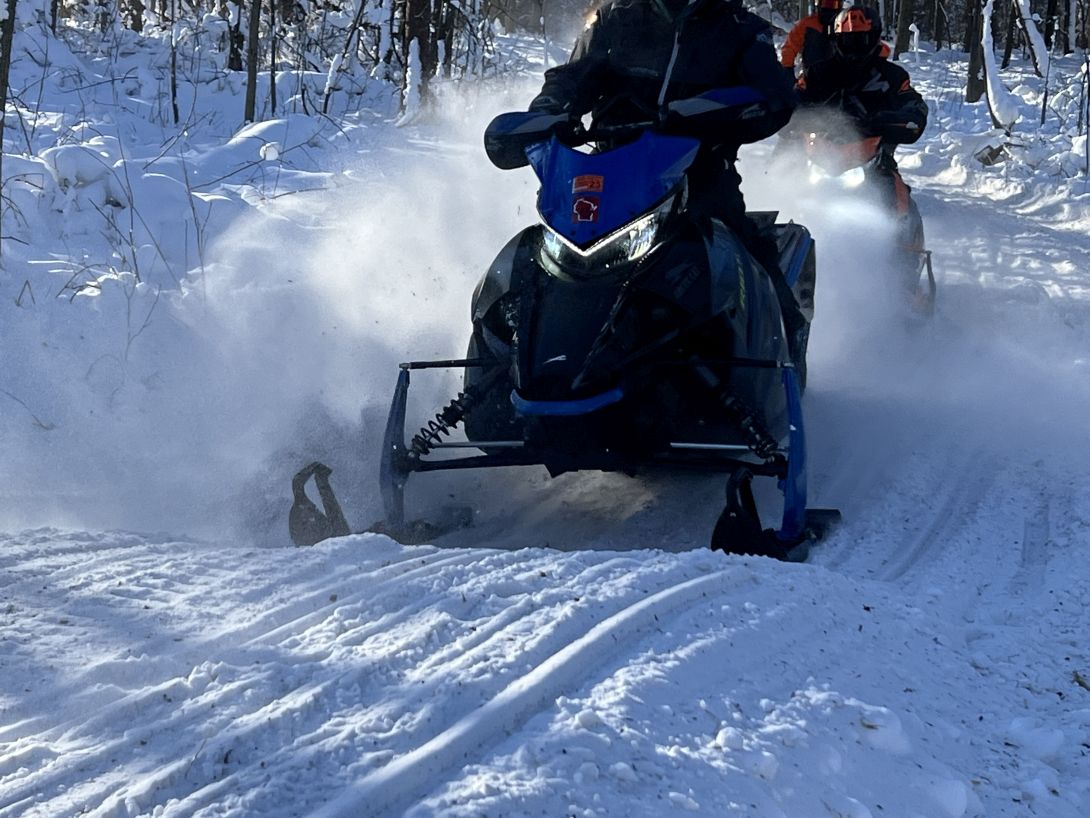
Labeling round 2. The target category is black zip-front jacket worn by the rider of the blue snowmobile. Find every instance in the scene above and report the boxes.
[531,0,795,160]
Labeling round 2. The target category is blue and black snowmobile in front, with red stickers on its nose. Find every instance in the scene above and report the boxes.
[294,92,838,560]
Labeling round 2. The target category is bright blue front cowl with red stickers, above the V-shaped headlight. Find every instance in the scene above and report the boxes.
[526,131,700,248]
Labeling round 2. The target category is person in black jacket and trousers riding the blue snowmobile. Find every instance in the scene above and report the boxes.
[530,0,804,341]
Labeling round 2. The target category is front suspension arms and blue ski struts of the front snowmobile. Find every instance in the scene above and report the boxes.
[361,359,840,561]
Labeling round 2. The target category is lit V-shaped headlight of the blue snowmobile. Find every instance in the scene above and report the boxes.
[542,195,678,276]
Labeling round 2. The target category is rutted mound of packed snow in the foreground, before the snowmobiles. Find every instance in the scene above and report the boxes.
[0,521,1090,817]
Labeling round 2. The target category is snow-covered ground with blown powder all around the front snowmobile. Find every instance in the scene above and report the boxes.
[0,22,1090,818]
